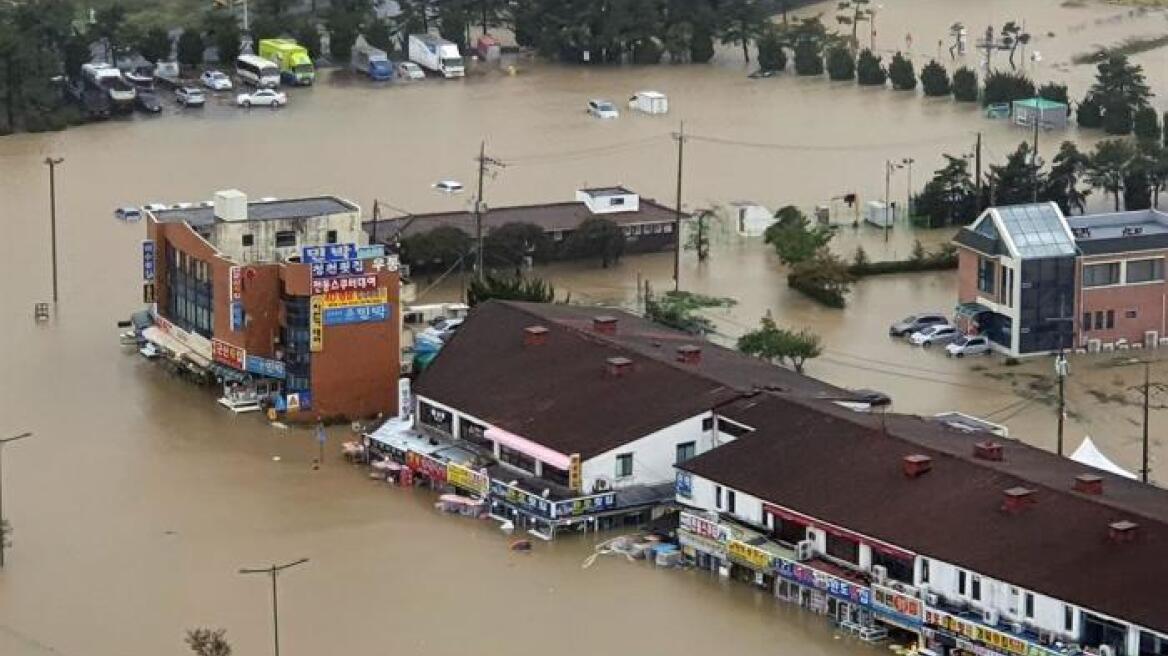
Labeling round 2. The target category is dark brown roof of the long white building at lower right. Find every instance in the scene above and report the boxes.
[681,395,1168,630]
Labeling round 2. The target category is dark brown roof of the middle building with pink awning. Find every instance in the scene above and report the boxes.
[417,301,847,459]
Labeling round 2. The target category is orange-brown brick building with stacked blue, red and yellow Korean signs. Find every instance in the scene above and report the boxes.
[142,190,401,419]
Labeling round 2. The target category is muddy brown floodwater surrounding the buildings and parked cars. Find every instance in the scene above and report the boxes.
[0,0,1168,656]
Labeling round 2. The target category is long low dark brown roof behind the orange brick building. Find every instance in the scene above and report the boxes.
[362,198,677,238]
